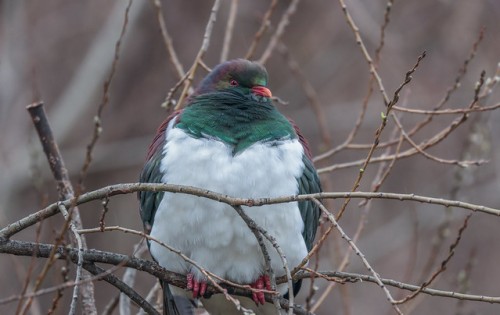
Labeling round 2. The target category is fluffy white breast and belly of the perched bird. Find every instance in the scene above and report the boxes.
[151,122,307,283]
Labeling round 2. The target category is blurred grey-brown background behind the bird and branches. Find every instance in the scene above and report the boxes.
[0,0,500,314]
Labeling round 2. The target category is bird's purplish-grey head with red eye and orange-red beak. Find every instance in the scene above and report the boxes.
[194,59,272,99]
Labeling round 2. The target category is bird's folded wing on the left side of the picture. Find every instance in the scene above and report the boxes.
[138,112,179,234]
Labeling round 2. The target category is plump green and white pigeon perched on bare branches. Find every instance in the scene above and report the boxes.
[138,59,321,315]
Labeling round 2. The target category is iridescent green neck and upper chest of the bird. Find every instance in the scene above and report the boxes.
[176,93,297,154]
